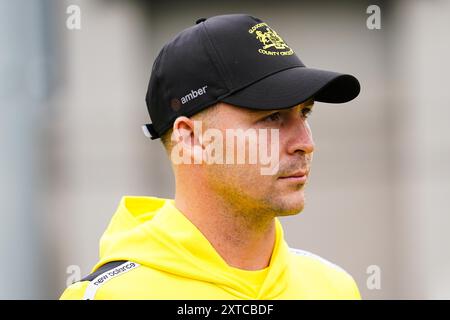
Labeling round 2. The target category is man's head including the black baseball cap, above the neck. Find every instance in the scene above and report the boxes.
[143,14,360,215]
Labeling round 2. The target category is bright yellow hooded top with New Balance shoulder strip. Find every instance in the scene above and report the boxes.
[61,196,361,300]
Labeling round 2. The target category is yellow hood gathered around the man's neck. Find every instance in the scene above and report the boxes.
[93,196,289,299]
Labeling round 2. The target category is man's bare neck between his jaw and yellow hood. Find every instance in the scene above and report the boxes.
[175,188,276,270]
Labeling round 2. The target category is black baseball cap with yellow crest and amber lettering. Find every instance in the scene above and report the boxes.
[143,14,360,139]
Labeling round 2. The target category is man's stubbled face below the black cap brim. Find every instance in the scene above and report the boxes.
[202,100,314,216]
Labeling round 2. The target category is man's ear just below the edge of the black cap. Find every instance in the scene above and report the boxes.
[171,116,203,164]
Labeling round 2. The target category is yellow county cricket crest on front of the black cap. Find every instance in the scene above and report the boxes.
[248,22,294,56]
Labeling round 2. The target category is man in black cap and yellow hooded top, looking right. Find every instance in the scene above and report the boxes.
[61,14,360,299]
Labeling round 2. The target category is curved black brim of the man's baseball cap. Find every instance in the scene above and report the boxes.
[221,67,360,110]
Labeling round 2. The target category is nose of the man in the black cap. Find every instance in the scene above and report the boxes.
[287,119,315,154]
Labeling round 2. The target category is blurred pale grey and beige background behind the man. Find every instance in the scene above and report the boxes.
[0,0,450,299]
